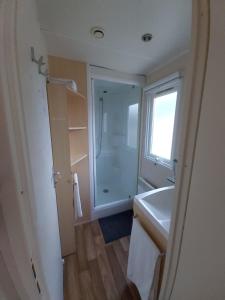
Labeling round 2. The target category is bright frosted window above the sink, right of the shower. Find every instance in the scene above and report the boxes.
[145,76,179,166]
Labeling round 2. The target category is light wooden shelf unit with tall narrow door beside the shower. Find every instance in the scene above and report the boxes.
[48,56,91,255]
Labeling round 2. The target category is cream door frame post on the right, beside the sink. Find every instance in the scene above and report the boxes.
[159,0,210,300]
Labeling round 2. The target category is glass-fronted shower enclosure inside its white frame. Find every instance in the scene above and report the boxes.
[93,80,141,207]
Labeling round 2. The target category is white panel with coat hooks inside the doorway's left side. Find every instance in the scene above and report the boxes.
[16,0,63,300]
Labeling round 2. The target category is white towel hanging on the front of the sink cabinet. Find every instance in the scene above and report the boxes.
[127,218,162,300]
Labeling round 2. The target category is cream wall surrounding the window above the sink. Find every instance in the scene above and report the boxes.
[140,54,189,187]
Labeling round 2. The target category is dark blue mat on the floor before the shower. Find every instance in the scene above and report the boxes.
[98,210,133,244]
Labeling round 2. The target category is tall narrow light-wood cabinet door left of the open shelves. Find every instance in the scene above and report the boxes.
[48,84,75,256]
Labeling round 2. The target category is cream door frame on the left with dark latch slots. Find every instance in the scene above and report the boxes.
[0,0,54,300]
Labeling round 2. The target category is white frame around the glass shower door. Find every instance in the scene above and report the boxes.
[87,65,146,219]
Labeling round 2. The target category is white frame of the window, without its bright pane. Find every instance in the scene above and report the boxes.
[144,73,181,169]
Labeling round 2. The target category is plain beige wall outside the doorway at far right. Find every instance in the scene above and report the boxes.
[171,0,225,300]
